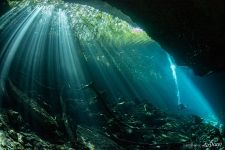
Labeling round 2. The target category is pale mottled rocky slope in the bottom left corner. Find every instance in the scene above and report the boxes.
[0,110,73,150]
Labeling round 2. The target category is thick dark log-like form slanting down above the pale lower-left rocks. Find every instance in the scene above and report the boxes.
[7,81,60,142]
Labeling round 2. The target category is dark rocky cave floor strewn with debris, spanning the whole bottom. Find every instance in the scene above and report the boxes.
[0,82,225,150]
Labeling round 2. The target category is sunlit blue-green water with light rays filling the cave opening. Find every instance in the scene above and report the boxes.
[0,1,217,125]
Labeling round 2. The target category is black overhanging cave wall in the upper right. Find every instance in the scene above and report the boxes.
[104,0,225,75]
